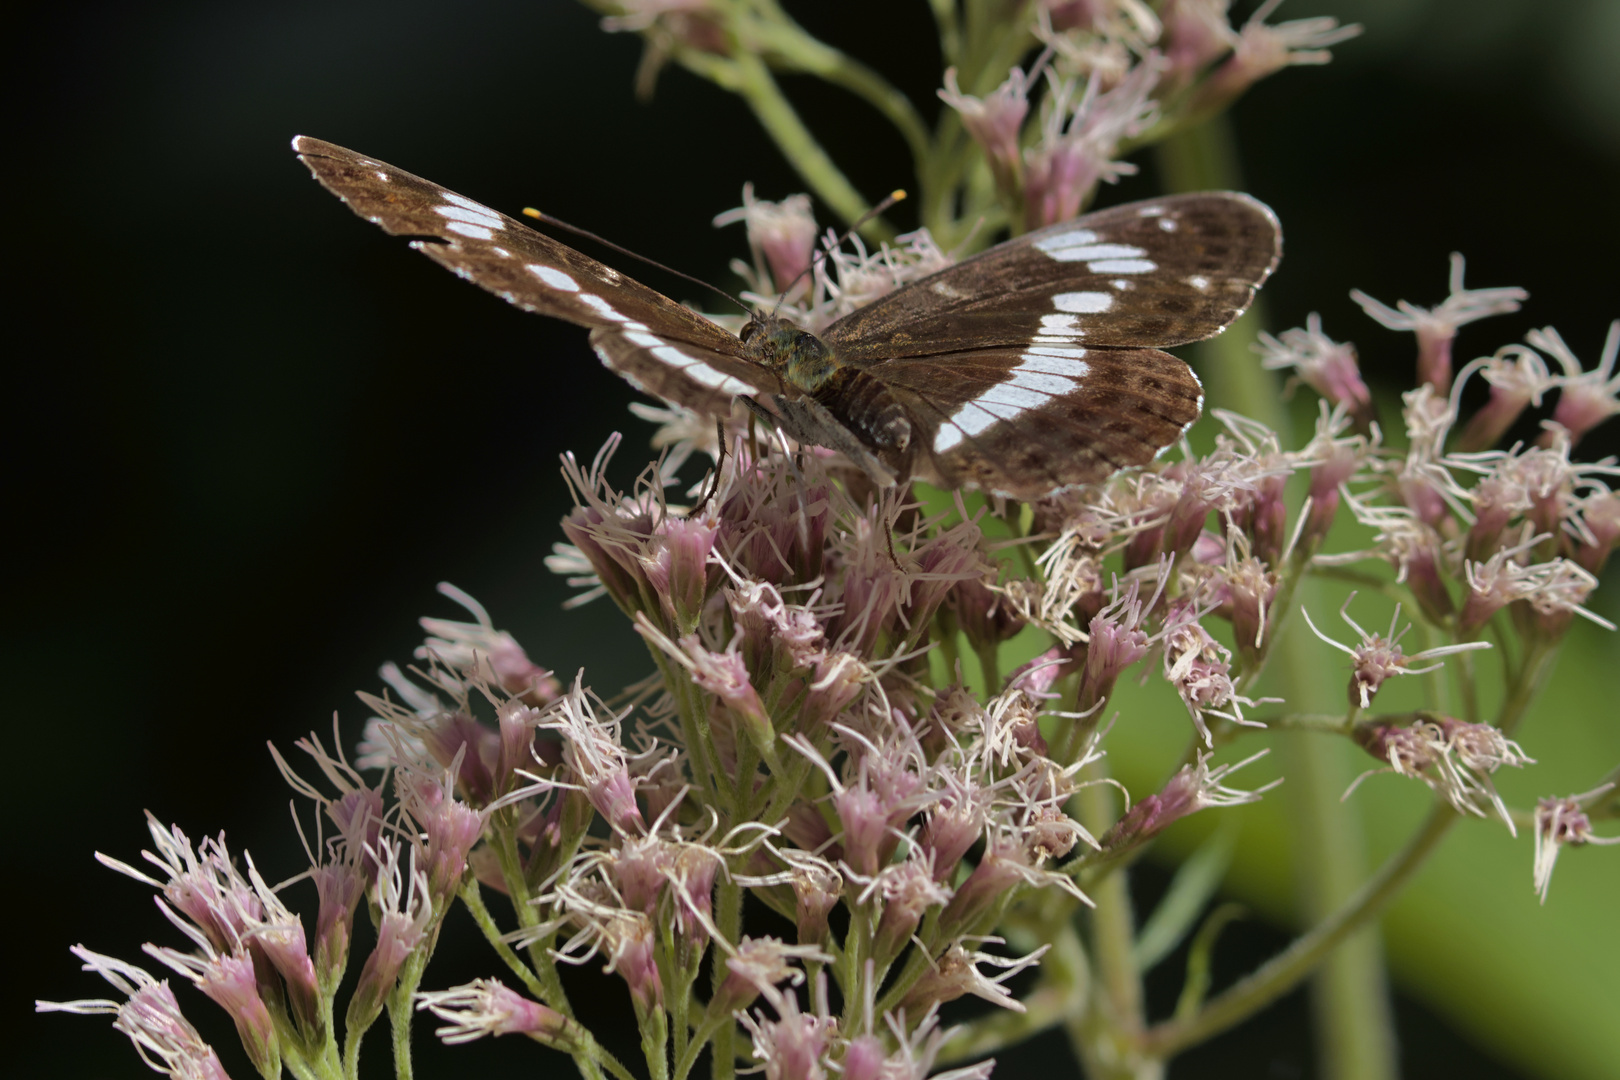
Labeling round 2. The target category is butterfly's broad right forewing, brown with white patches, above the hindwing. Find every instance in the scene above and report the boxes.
[825,191,1281,364]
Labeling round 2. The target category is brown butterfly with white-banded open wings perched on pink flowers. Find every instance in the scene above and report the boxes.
[293,136,1281,500]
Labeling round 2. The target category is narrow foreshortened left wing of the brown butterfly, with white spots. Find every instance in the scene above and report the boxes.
[293,136,758,411]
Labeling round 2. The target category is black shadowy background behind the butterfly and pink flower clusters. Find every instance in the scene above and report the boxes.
[3,0,1620,1080]
